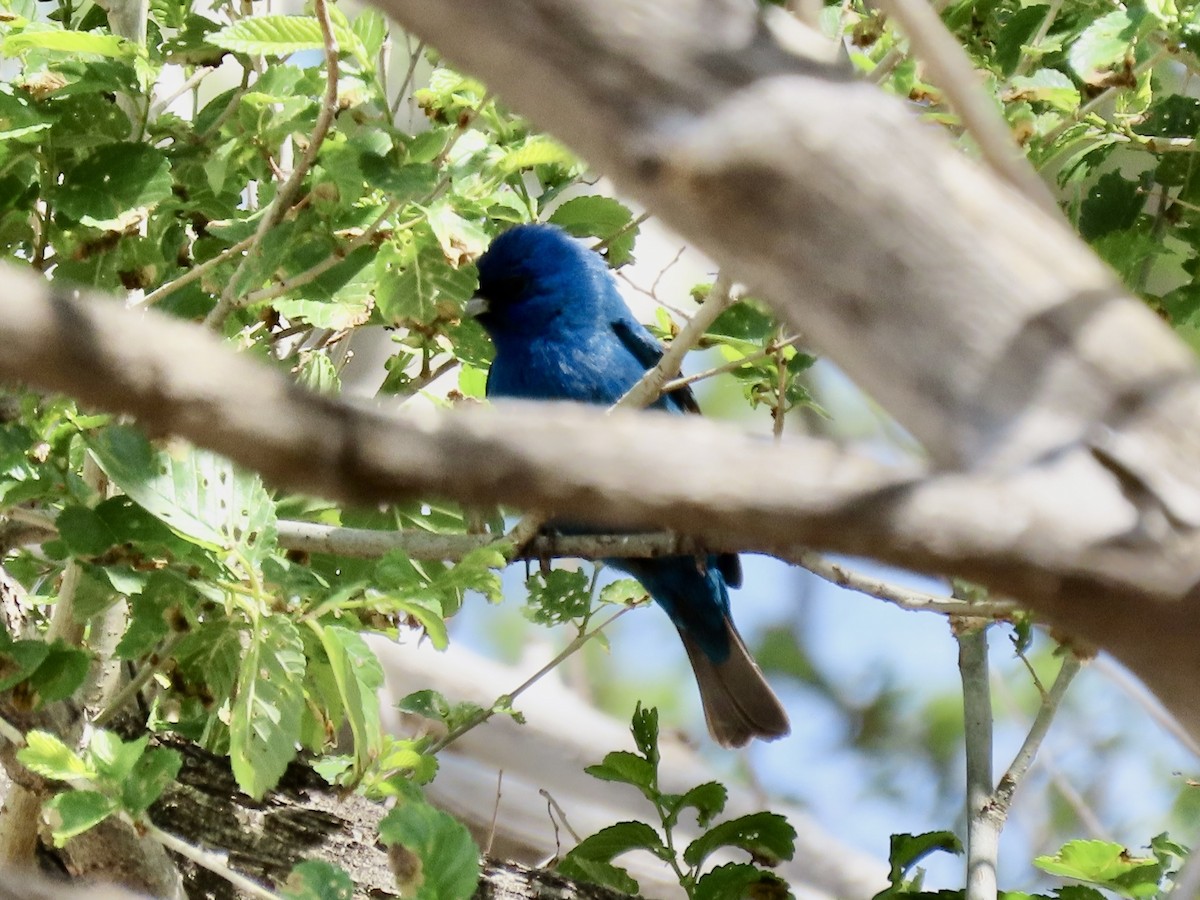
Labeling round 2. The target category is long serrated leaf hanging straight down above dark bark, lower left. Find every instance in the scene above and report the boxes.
[229,616,305,798]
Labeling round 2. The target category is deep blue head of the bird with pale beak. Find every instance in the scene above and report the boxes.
[467,224,620,341]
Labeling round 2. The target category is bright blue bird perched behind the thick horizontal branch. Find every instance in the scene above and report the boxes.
[468,224,790,746]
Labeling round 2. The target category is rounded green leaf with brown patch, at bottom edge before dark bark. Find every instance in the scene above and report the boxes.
[379,800,479,900]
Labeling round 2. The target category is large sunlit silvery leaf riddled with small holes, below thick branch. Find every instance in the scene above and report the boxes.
[88,426,275,563]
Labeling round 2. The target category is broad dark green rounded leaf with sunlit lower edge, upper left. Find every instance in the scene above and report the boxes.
[55,143,172,232]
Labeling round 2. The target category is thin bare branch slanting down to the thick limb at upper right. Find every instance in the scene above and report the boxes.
[880,0,1060,217]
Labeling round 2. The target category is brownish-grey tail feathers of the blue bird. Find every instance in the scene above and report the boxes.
[679,617,792,746]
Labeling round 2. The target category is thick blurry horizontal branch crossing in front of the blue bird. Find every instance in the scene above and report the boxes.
[0,270,1200,731]
